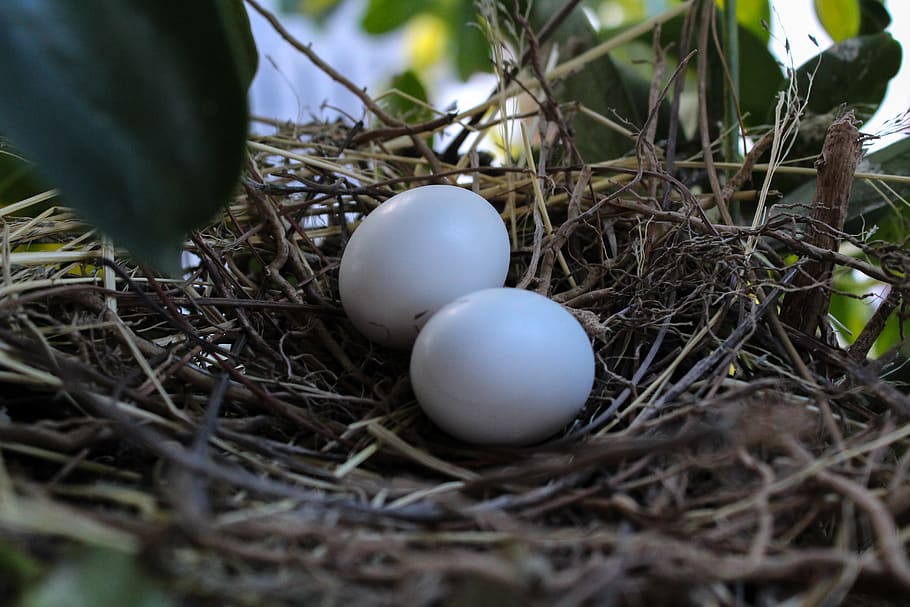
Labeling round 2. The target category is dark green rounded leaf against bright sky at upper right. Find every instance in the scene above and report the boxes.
[796,32,901,128]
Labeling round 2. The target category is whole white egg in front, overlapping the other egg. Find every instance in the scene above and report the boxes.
[411,288,594,445]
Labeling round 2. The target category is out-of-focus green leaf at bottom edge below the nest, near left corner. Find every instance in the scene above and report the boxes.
[20,550,175,607]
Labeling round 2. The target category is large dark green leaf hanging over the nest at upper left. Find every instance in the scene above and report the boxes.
[0,0,249,274]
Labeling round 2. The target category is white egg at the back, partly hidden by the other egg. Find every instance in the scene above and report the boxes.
[338,185,509,347]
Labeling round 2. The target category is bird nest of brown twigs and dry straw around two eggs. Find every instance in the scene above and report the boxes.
[0,19,910,607]
